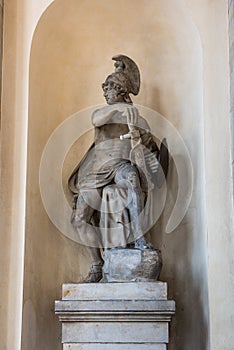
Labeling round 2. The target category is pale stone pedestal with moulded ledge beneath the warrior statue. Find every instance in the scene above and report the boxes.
[55,282,175,350]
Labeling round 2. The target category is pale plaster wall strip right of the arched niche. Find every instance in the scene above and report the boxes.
[189,1,234,350]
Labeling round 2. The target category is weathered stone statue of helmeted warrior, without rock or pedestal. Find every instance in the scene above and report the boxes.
[69,55,168,282]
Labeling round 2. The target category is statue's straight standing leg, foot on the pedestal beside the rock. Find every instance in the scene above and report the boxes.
[71,191,103,282]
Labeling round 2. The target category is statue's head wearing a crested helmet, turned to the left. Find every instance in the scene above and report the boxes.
[102,55,140,104]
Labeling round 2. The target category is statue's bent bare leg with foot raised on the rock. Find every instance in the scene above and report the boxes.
[115,163,153,249]
